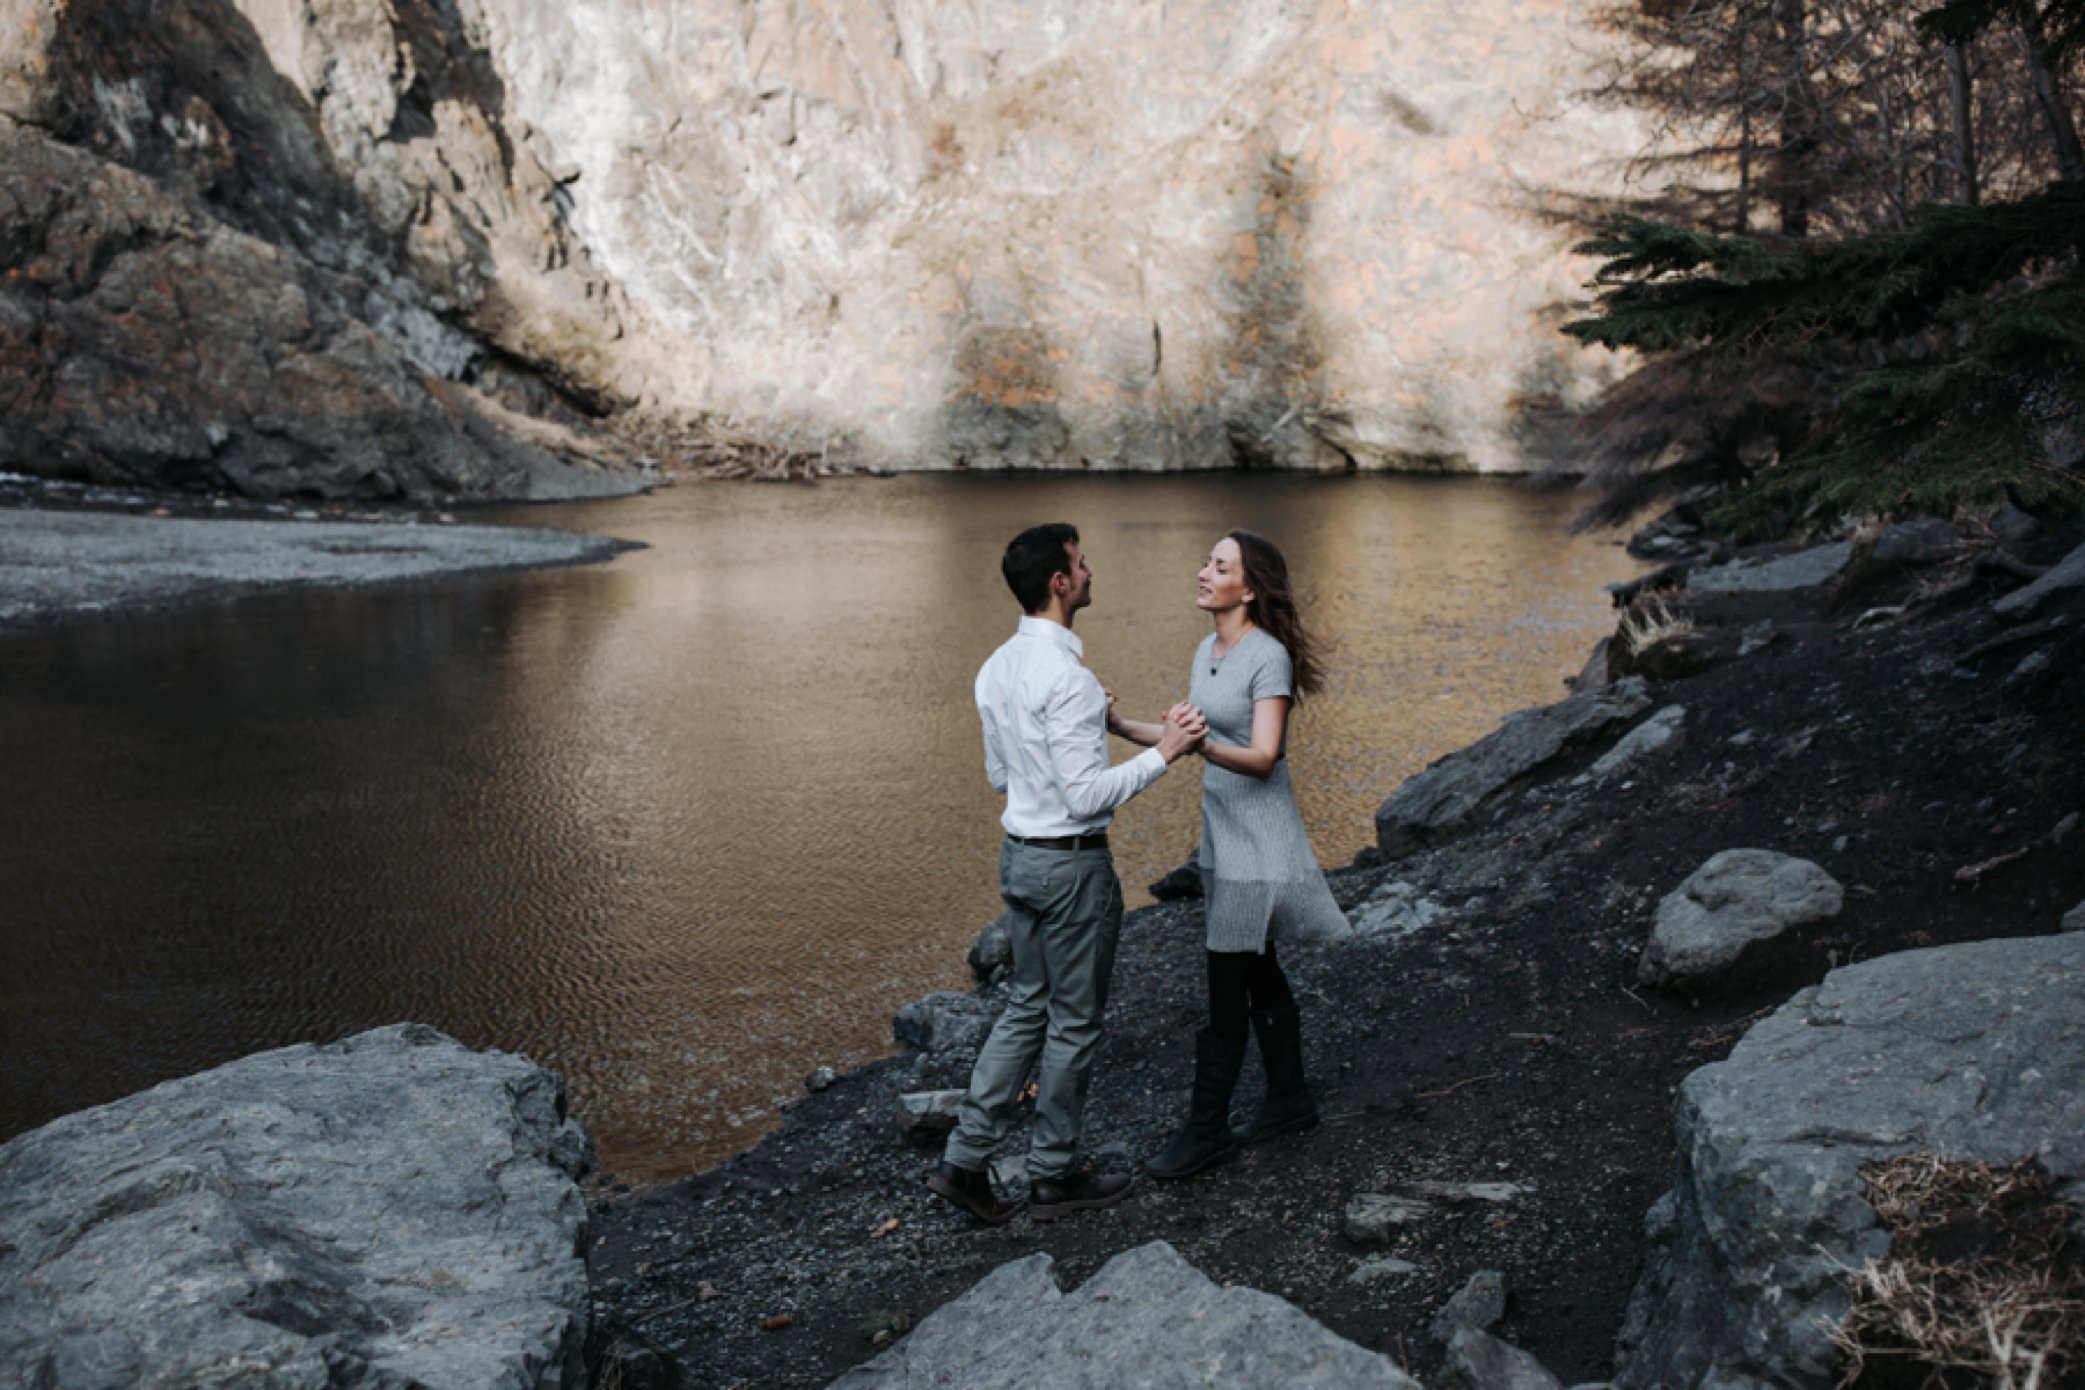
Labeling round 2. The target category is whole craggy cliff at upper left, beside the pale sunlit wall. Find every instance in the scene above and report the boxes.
[0,0,650,498]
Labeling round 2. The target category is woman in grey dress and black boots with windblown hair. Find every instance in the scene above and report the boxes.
[1109,531,1349,1177]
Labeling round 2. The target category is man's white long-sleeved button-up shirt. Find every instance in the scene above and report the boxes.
[976,617,1166,838]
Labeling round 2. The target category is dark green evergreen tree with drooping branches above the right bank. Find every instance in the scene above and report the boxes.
[1566,0,2085,536]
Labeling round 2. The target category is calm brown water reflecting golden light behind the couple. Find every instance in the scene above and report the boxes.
[0,475,1635,1180]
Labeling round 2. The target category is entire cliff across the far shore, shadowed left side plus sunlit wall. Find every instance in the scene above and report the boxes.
[0,0,1637,492]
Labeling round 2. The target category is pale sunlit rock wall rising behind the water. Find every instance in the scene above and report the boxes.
[482,0,1639,469]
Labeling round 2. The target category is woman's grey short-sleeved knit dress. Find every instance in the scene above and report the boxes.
[1188,627,1351,952]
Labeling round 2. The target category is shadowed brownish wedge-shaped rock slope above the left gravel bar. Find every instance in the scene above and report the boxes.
[0,121,634,500]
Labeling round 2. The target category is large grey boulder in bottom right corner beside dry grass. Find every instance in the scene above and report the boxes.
[1616,936,2085,1390]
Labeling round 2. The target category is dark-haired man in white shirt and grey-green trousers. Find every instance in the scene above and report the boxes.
[926,523,1205,1223]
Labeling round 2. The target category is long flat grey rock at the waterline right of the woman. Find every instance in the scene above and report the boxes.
[1376,677,1651,859]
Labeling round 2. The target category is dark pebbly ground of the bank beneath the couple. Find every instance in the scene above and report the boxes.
[590,533,2085,1388]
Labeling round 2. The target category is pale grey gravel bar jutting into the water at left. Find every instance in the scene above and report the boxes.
[0,506,642,629]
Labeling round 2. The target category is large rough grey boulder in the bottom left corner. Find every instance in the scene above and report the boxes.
[0,1023,586,1390]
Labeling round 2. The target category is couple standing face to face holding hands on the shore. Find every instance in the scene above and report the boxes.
[926,523,1347,1223]
